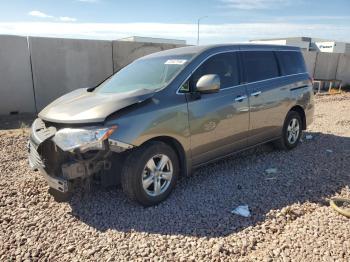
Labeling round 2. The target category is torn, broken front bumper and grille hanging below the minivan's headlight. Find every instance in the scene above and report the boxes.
[28,118,133,193]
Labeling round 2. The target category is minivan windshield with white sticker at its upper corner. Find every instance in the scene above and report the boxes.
[96,55,193,93]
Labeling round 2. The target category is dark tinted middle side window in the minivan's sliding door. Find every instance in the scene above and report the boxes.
[242,51,279,83]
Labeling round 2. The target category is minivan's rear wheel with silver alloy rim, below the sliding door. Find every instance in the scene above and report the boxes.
[273,111,302,150]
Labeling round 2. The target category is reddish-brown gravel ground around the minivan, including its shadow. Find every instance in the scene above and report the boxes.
[0,94,350,261]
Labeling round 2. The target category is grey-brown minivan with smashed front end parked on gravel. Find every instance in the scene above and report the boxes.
[28,44,314,206]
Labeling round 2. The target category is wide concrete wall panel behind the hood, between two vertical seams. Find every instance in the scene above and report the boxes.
[29,37,113,111]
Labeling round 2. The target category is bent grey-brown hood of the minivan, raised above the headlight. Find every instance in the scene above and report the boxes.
[39,88,155,124]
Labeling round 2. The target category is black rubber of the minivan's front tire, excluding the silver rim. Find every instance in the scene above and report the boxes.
[125,142,179,206]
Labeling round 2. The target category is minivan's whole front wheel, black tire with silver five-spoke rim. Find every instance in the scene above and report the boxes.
[121,141,179,206]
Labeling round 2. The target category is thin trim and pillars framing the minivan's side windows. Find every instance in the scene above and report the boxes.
[176,49,309,95]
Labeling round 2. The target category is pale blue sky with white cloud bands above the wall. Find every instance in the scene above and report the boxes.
[0,0,350,44]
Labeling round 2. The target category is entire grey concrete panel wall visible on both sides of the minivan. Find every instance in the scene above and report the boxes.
[0,36,350,115]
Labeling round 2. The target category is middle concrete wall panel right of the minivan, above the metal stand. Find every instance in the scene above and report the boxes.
[314,53,339,79]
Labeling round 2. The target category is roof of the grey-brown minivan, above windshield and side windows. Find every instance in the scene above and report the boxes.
[144,43,300,58]
